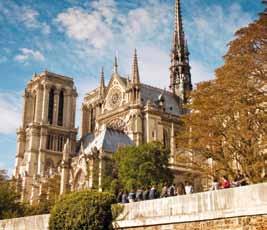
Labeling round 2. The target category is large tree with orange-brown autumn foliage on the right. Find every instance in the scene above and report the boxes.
[177,3,267,183]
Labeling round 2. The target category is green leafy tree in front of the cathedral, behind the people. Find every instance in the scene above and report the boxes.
[114,143,173,190]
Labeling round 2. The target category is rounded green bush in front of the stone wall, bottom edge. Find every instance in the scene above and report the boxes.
[49,191,116,230]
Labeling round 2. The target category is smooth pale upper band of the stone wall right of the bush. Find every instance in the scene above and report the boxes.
[114,183,267,229]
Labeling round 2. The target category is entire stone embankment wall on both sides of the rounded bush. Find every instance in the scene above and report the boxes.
[0,183,267,230]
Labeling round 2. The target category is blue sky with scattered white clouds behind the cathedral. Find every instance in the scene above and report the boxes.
[0,0,263,174]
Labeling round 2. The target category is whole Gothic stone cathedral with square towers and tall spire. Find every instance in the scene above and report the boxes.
[14,0,192,203]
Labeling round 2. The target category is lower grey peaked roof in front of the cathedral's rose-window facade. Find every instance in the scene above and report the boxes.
[80,128,133,154]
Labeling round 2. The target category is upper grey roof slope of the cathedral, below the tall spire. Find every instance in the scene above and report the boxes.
[141,84,181,115]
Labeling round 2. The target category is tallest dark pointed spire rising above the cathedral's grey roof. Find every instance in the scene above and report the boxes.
[170,0,192,103]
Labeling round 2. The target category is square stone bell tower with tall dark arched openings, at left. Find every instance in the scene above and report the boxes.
[14,71,77,202]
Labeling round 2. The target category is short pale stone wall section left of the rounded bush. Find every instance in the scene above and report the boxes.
[0,215,49,230]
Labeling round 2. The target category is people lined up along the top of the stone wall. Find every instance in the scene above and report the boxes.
[117,171,248,204]
